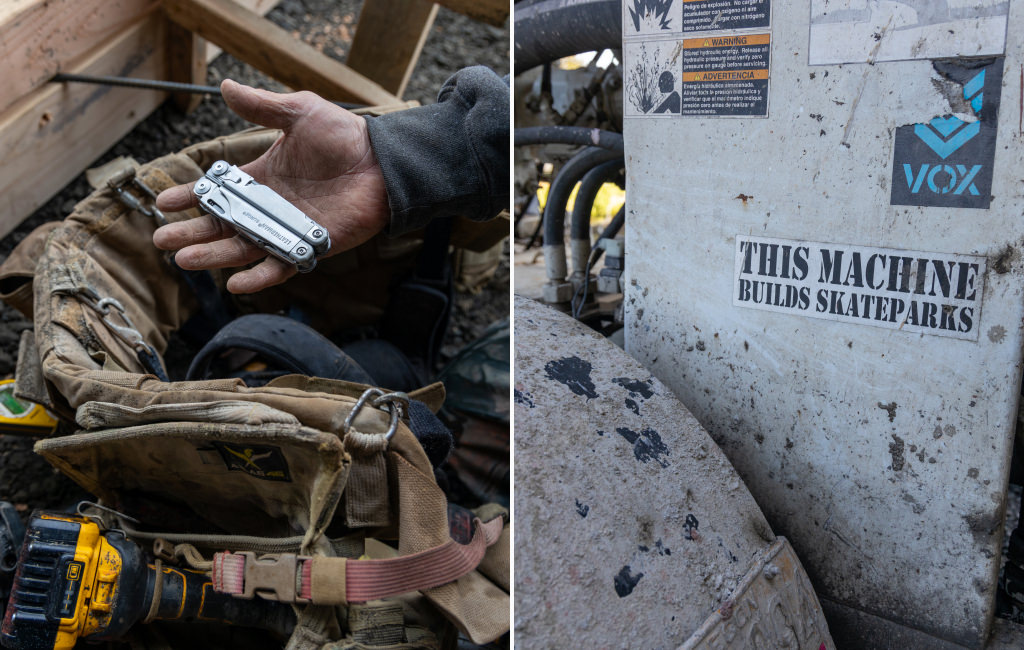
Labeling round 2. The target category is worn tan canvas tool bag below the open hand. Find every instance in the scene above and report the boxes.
[0,130,509,647]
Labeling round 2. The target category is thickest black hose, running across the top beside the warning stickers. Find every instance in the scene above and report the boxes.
[514,0,623,75]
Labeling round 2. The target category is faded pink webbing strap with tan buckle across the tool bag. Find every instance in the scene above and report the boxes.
[213,517,505,605]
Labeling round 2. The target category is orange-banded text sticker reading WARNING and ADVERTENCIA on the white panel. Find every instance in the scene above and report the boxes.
[682,34,771,117]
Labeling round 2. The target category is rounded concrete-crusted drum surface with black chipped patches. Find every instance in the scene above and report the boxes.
[514,297,831,650]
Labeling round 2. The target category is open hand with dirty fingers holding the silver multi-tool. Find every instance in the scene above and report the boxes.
[153,80,391,294]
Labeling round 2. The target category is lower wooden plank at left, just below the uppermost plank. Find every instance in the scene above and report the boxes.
[0,12,167,236]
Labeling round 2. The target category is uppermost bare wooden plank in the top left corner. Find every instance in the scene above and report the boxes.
[0,0,158,111]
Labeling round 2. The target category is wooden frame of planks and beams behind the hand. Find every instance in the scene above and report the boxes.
[0,0,509,236]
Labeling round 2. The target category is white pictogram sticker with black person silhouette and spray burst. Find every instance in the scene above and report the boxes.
[623,41,682,118]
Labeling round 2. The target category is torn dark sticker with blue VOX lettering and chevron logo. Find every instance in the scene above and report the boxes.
[890,58,1004,210]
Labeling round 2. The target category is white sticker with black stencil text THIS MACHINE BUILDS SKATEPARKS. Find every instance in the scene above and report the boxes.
[732,235,985,341]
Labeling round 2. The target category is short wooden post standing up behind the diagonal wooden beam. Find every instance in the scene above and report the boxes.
[345,0,437,97]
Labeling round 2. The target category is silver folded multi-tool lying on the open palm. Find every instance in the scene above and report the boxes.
[193,161,331,273]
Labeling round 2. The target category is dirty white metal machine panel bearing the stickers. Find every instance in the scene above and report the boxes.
[625,0,1024,647]
